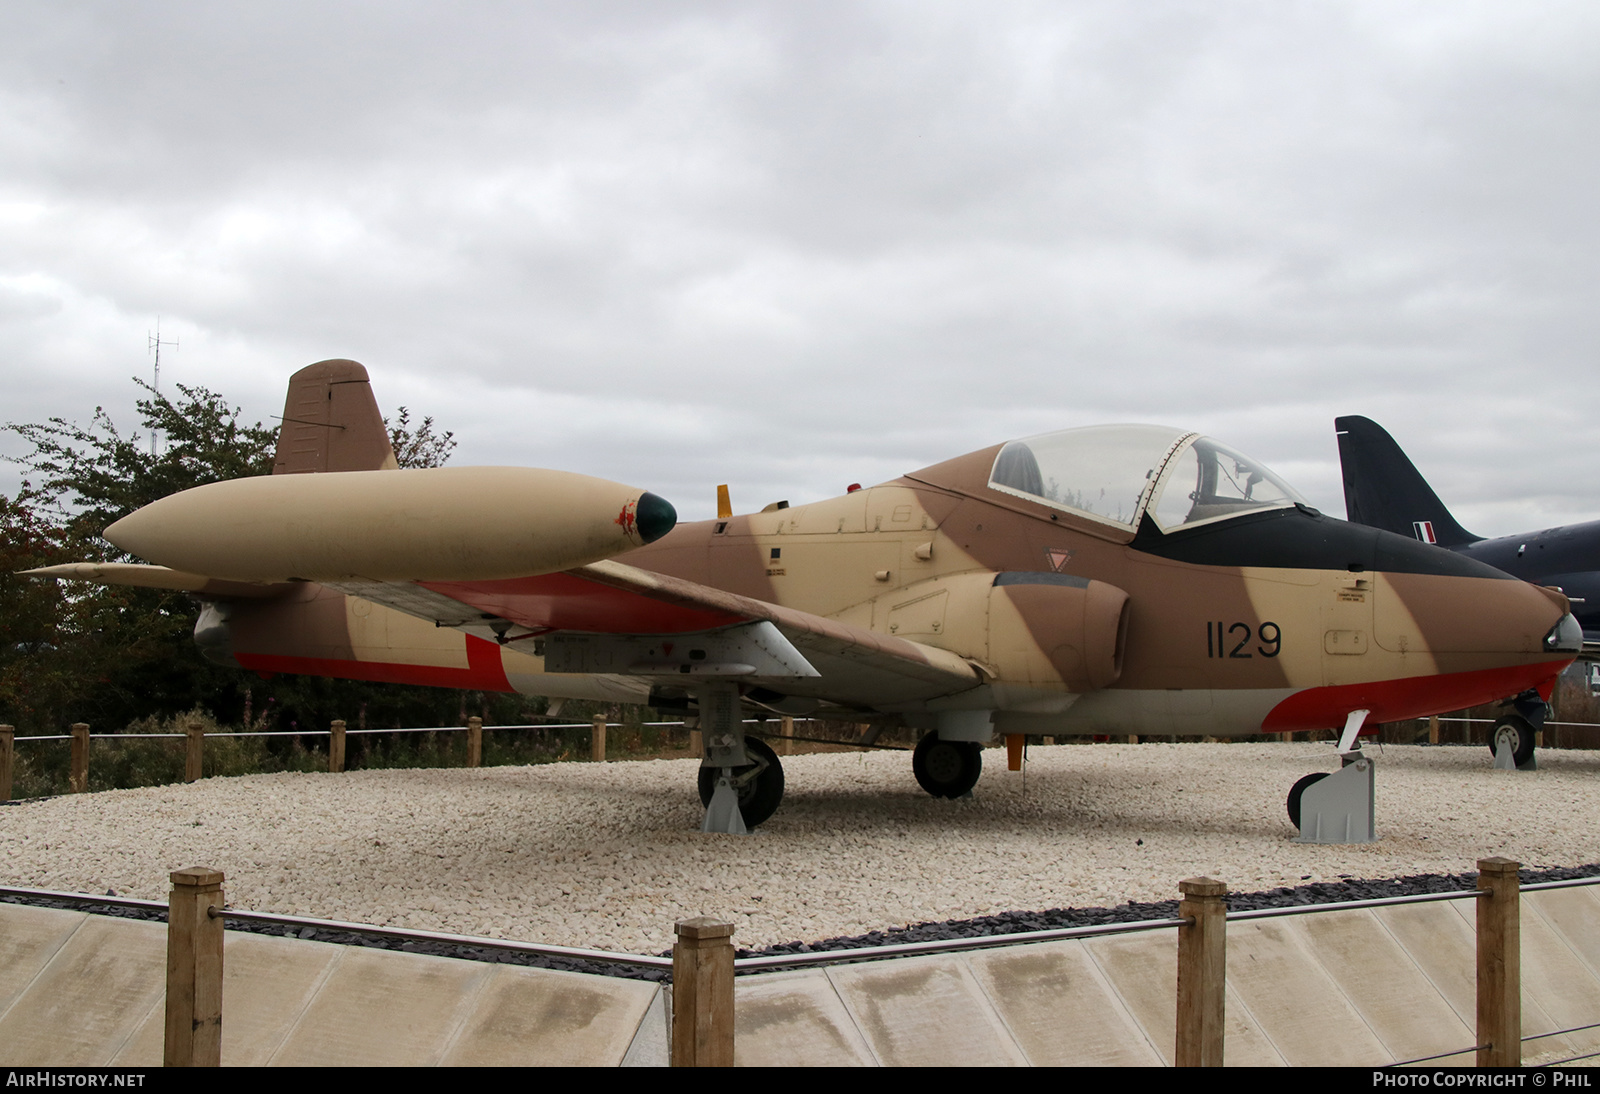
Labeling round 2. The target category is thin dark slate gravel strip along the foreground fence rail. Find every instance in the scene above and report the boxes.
[0,862,1600,982]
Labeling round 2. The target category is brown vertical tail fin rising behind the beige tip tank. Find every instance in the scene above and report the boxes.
[272,360,398,475]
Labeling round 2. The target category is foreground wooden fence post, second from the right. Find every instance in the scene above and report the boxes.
[1173,878,1227,1067]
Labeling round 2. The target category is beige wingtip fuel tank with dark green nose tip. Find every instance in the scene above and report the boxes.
[106,467,677,581]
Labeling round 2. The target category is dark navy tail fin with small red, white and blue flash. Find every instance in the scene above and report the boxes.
[1333,414,1482,547]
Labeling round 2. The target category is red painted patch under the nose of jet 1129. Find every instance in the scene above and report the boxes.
[1261,662,1571,733]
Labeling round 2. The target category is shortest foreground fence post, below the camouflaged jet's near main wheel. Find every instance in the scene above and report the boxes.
[672,916,733,1067]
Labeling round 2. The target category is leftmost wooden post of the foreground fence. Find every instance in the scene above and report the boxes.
[163,867,222,1067]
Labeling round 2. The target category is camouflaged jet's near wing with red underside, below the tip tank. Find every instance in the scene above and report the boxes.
[325,561,981,707]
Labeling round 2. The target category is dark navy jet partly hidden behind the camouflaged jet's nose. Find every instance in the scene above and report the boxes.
[1333,414,1600,765]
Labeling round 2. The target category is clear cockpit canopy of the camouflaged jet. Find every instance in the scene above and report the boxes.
[989,425,1306,531]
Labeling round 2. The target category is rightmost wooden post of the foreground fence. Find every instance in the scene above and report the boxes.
[1478,857,1522,1067]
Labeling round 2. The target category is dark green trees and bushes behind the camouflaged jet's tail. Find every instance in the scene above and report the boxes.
[0,379,461,728]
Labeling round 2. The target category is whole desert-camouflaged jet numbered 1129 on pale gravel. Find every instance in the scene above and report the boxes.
[21,361,1579,832]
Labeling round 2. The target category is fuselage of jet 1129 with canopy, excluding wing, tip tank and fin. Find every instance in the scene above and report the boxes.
[197,427,1576,736]
